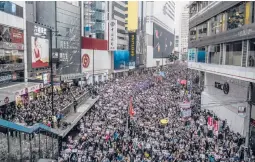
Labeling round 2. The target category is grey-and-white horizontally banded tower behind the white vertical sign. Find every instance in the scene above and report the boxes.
[107,1,128,50]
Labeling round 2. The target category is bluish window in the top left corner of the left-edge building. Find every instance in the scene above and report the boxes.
[0,1,23,18]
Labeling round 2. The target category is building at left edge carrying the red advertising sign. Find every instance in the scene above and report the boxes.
[0,1,27,104]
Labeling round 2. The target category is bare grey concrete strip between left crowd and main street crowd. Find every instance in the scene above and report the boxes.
[55,96,99,137]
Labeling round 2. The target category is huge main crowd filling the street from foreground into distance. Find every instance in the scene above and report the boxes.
[59,65,251,162]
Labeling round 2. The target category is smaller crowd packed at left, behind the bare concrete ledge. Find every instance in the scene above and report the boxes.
[0,86,88,127]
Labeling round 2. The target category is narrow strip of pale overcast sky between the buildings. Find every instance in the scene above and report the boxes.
[174,1,189,35]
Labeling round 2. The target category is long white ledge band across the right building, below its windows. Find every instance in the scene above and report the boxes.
[188,62,255,82]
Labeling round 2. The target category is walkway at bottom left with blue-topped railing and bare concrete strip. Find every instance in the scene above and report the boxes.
[0,97,99,162]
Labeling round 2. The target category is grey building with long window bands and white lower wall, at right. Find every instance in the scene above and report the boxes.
[188,1,255,139]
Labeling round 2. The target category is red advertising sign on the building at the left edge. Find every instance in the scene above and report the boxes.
[0,25,24,44]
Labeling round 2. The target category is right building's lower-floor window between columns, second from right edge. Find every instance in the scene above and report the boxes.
[226,41,242,66]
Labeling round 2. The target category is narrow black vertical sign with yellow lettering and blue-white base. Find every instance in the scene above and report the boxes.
[128,33,136,69]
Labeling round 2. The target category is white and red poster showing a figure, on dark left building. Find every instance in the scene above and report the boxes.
[31,36,49,68]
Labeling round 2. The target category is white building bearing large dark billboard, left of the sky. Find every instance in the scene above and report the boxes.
[144,1,175,67]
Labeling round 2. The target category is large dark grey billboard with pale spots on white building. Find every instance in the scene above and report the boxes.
[153,23,174,58]
